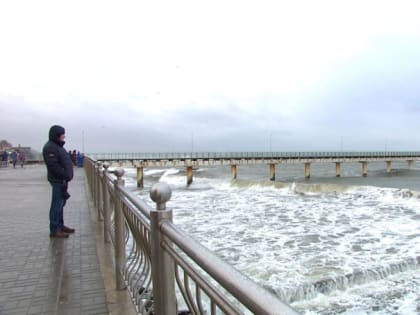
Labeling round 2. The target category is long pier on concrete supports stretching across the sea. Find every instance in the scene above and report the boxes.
[91,152,420,188]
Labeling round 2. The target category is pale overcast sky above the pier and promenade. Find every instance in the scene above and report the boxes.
[0,0,420,152]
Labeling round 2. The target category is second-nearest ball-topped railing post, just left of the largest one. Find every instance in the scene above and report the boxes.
[114,168,126,290]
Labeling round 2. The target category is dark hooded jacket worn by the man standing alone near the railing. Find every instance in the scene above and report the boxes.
[42,126,73,184]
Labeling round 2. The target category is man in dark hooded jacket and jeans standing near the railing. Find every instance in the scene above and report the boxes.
[42,125,75,238]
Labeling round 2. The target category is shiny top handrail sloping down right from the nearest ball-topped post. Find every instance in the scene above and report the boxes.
[161,222,298,315]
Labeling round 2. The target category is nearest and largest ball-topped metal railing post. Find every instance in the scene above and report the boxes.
[150,183,177,315]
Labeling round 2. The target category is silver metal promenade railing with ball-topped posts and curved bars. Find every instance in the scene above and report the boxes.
[85,157,298,315]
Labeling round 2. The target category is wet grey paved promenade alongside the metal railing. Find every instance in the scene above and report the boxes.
[0,165,135,315]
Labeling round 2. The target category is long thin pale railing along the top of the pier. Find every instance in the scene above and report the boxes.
[89,151,420,161]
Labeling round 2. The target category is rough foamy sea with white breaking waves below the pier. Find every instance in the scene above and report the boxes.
[120,162,420,315]
